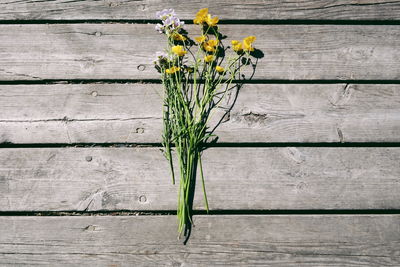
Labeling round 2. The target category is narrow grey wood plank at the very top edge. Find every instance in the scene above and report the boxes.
[0,0,400,20]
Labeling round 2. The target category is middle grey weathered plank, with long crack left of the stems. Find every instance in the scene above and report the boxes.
[0,84,400,143]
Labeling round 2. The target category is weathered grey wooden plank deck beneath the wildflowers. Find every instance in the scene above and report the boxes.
[0,0,400,267]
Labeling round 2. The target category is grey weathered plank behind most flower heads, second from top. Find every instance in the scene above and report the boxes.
[0,24,400,81]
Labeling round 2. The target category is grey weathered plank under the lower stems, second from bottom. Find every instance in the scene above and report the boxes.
[0,147,400,211]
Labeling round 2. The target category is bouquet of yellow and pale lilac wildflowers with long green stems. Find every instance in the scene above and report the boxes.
[154,8,256,240]
